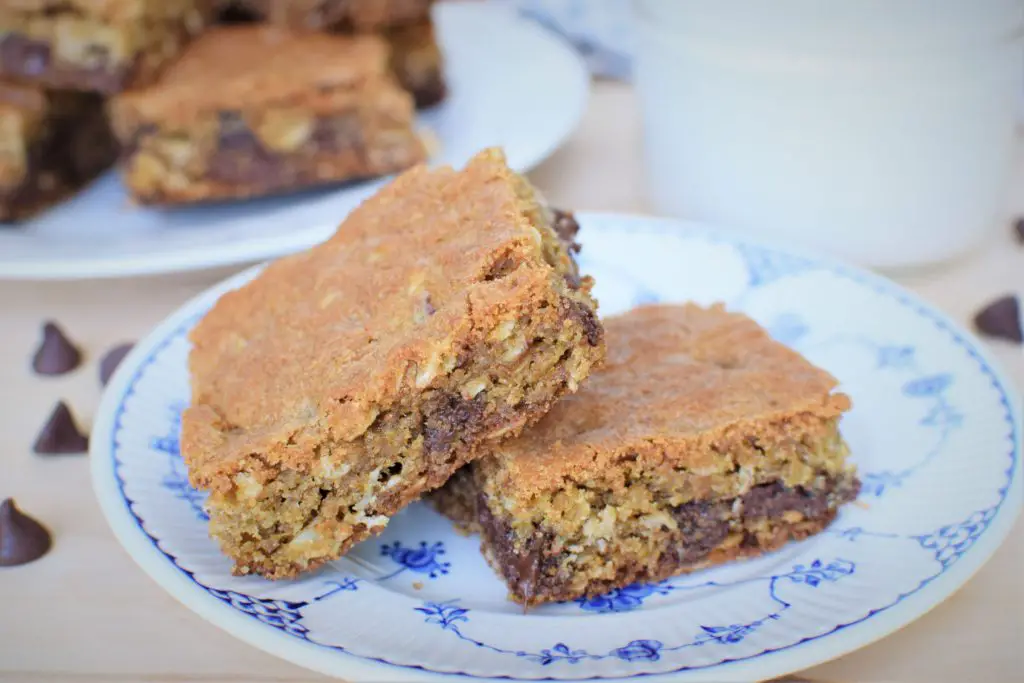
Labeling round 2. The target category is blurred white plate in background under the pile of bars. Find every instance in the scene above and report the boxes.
[0,3,589,280]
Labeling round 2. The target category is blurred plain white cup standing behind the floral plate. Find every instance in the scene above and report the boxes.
[634,0,1024,267]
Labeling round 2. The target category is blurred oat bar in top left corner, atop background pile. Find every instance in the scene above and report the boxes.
[0,0,213,94]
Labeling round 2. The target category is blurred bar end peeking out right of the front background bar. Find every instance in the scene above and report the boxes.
[384,20,447,109]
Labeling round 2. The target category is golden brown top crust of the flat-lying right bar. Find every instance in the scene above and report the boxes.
[479,304,850,500]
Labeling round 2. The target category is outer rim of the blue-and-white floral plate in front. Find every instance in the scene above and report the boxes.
[90,211,1024,683]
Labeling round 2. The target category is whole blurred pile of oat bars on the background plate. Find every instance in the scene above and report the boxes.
[0,0,445,221]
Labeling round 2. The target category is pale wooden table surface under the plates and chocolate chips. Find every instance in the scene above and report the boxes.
[0,83,1024,683]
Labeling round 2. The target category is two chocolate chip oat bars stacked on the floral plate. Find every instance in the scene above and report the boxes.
[182,151,859,605]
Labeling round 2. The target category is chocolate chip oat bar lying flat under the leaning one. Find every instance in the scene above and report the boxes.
[434,305,859,605]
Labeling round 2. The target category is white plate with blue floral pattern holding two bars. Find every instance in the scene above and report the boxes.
[92,214,1022,682]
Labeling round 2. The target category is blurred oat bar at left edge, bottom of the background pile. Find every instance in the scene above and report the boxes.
[0,83,117,222]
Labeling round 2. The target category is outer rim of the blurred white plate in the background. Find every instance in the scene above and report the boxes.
[0,3,592,283]
